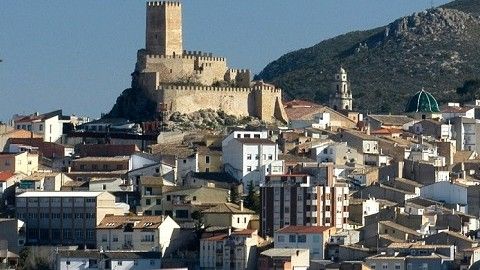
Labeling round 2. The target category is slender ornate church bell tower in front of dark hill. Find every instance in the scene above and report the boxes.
[330,67,353,111]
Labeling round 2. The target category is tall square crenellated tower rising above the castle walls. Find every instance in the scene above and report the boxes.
[145,2,183,55]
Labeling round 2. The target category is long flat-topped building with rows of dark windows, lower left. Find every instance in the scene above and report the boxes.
[16,191,128,247]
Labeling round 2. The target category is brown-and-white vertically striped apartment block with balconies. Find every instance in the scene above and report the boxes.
[260,171,349,236]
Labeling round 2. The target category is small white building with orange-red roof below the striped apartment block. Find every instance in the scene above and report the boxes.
[274,226,336,260]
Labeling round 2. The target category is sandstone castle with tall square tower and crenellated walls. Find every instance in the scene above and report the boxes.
[132,2,288,122]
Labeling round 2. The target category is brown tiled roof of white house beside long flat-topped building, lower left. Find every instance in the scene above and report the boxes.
[97,216,164,229]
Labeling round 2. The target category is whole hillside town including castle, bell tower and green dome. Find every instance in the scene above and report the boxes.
[0,2,480,270]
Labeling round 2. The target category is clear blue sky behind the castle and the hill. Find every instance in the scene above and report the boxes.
[0,0,449,121]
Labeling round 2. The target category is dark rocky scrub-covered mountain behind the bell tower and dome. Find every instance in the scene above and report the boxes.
[258,0,480,113]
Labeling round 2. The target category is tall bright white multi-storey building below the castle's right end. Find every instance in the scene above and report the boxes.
[222,133,279,192]
